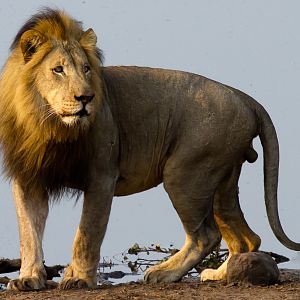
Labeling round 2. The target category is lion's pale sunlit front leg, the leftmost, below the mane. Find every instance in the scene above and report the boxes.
[8,180,48,291]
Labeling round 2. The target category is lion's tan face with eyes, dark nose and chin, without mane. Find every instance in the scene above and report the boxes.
[36,42,95,126]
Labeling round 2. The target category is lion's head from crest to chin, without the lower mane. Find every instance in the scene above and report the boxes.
[8,9,101,130]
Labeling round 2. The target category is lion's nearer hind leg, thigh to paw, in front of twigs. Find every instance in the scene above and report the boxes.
[145,161,221,283]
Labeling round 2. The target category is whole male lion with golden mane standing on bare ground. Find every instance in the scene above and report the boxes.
[0,9,300,290]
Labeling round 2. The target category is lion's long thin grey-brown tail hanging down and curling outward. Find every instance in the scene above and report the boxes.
[257,104,300,251]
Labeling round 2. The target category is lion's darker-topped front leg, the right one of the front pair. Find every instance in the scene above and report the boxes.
[59,183,113,289]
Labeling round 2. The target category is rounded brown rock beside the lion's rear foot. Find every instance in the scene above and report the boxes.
[227,252,280,285]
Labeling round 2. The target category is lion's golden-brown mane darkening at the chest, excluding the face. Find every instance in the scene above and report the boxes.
[0,8,102,196]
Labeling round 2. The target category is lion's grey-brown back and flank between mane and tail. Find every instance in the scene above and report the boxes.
[102,67,257,195]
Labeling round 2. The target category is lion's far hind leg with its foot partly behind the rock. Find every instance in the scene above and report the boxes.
[201,166,260,281]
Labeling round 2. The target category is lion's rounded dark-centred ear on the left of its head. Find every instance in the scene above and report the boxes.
[20,29,46,62]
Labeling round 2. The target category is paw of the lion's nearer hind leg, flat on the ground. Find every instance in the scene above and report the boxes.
[144,265,182,283]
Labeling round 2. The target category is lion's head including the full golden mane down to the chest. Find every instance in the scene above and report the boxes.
[0,9,102,195]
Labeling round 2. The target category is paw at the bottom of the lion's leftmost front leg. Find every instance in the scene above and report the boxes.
[7,277,46,291]
